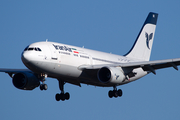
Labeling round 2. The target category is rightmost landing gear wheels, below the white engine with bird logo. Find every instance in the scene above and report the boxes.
[108,86,123,98]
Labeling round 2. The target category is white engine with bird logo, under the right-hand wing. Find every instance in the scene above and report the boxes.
[97,67,126,84]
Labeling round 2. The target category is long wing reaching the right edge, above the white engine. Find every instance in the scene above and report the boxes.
[79,58,180,74]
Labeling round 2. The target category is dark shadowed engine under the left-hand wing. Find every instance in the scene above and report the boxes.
[12,72,40,90]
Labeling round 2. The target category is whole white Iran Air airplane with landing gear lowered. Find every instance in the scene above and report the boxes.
[0,12,180,101]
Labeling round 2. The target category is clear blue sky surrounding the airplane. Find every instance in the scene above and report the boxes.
[0,0,180,120]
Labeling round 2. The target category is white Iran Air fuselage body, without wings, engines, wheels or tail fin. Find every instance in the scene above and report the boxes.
[22,42,147,86]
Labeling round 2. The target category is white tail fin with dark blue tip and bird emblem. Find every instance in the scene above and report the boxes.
[124,12,158,61]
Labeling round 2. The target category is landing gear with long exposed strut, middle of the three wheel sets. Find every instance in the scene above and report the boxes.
[55,80,70,101]
